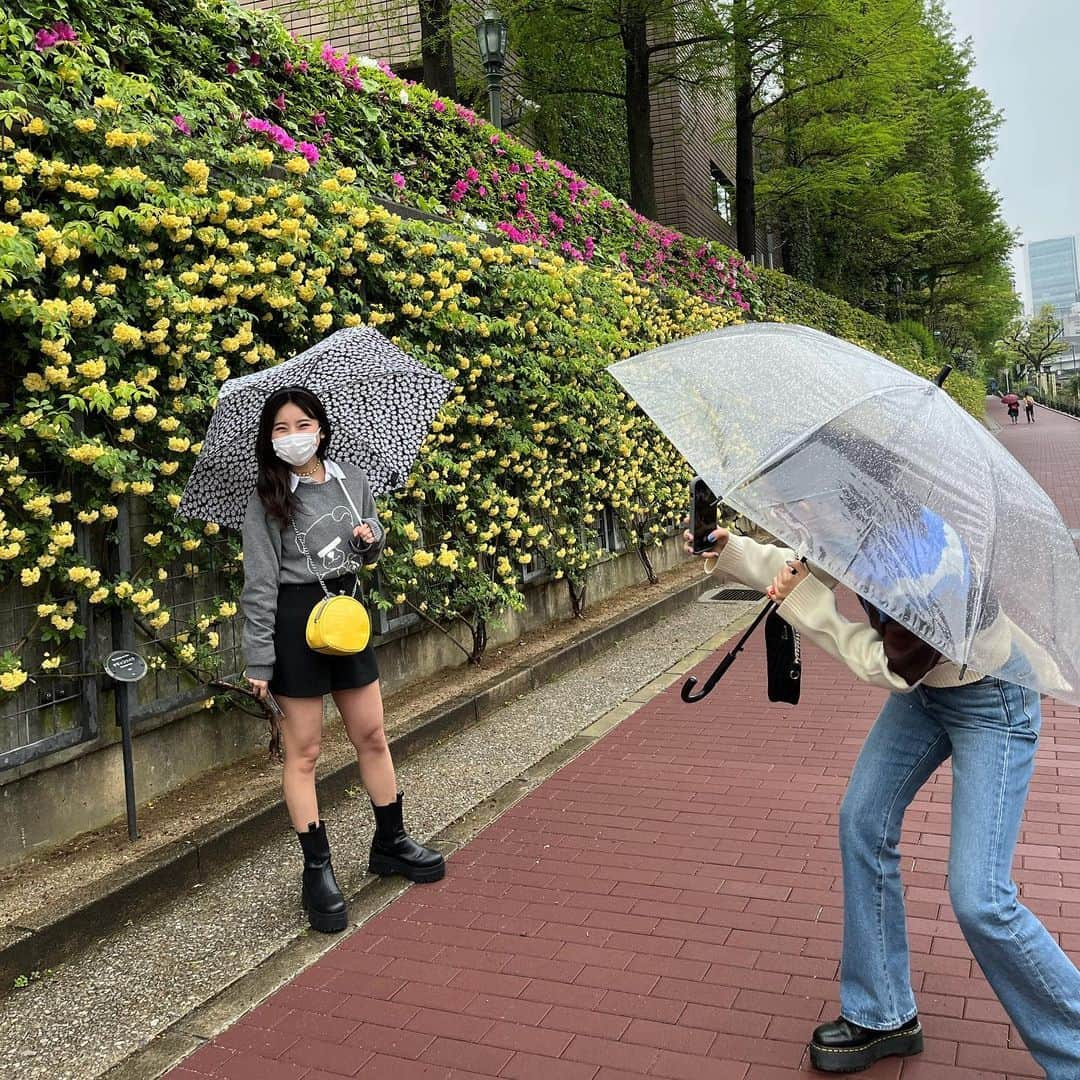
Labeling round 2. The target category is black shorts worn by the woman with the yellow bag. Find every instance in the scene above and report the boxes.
[270,576,379,698]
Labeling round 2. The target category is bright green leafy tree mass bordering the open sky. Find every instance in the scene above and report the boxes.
[759,3,1017,349]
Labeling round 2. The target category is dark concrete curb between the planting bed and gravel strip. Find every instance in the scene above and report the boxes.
[0,575,716,995]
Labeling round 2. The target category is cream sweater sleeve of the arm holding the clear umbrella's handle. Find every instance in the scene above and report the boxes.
[778,575,913,693]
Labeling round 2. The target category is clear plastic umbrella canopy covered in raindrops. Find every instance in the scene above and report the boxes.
[610,323,1080,702]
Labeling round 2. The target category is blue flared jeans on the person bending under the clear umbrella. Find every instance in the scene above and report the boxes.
[840,678,1080,1080]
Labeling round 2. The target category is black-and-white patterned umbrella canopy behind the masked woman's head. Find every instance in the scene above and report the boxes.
[177,327,453,528]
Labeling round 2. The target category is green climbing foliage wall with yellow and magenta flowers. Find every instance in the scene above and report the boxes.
[0,0,989,692]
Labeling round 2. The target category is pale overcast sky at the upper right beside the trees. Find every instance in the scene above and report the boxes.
[944,0,1080,313]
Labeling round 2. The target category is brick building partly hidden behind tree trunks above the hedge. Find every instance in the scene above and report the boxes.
[249,0,772,254]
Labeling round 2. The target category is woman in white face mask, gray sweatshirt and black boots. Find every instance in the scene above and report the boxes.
[241,388,446,933]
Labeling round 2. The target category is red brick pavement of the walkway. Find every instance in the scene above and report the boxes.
[168,409,1080,1080]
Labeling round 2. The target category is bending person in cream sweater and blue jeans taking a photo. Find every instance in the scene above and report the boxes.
[686,529,1080,1080]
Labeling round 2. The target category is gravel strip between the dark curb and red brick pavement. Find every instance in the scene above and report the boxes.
[0,603,750,1080]
